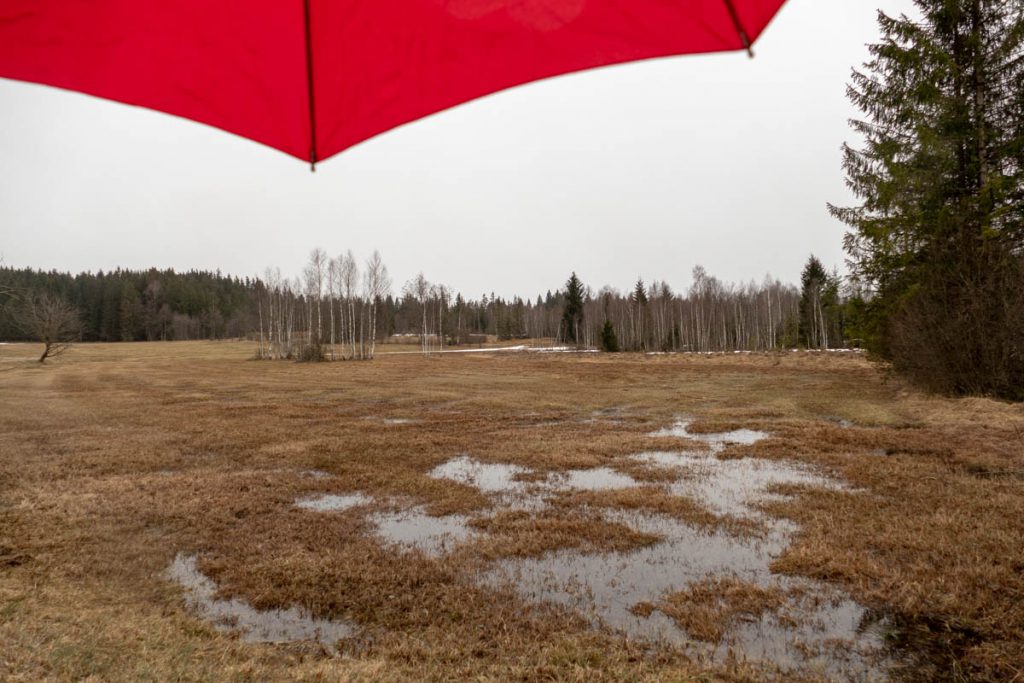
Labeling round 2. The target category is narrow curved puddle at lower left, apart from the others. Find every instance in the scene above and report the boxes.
[167,553,355,652]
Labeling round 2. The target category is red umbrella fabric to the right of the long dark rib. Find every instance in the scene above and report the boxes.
[311,0,783,159]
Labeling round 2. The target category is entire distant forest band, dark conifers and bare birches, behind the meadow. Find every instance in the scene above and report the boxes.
[0,249,850,358]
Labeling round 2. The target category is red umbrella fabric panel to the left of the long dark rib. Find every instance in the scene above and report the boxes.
[0,0,309,159]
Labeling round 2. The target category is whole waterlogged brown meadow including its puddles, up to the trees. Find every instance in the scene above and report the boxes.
[0,342,1024,681]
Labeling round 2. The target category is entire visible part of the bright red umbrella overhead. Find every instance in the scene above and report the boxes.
[0,0,784,164]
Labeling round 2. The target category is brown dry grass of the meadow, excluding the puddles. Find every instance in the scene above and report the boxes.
[0,342,1024,681]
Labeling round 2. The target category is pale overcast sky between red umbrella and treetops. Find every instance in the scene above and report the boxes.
[0,0,912,297]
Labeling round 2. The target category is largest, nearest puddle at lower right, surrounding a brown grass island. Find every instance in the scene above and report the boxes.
[483,511,884,676]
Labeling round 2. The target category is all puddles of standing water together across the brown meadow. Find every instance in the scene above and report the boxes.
[169,420,891,680]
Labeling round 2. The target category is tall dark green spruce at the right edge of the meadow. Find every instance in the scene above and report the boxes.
[829,0,1024,398]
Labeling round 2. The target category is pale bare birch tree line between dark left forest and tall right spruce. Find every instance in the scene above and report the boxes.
[254,248,859,360]
